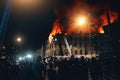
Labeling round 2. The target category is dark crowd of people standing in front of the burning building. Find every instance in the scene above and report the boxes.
[0,55,119,80]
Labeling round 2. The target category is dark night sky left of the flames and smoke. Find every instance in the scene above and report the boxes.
[0,0,55,49]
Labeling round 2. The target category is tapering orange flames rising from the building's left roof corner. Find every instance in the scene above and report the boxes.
[49,20,62,43]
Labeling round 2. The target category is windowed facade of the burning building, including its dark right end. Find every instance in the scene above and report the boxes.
[36,31,112,57]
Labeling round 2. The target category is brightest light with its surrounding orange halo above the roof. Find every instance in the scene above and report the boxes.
[67,12,90,34]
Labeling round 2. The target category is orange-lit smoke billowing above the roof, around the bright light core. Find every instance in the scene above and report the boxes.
[51,0,118,38]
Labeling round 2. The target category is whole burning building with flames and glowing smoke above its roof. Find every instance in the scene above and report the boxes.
[37,0,118,56]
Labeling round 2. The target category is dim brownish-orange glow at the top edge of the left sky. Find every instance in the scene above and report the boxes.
[11,0,44,14]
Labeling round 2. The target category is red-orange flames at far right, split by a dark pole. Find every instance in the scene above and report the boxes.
[100,11,118,26]
